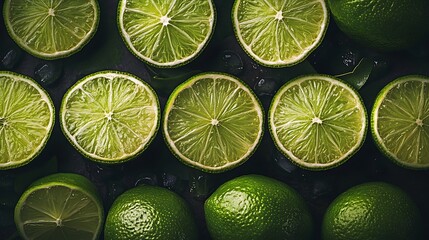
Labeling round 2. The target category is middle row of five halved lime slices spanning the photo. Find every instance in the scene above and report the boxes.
[0,71,429,172]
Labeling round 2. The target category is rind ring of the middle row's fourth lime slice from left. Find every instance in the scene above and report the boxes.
[268,74,368,171]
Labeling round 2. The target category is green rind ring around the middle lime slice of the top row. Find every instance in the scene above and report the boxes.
[116,0,217,68]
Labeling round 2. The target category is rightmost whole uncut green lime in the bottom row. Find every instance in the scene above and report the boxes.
[322,182,422,240]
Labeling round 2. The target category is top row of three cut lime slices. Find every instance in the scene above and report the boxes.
[3,0,329,67]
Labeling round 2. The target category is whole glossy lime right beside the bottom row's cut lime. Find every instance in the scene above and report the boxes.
[104,185,198,240]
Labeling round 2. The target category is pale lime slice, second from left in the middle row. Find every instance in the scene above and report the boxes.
[60,71,160,163]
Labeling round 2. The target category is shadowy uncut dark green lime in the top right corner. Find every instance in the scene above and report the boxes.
[328,0,429,51]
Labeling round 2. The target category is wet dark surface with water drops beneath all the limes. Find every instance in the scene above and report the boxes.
[0,0,429,239]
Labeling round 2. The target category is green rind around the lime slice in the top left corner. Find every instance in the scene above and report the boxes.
[3,0,100,60]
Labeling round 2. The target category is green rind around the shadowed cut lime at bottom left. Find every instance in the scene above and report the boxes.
[14,173,104,240]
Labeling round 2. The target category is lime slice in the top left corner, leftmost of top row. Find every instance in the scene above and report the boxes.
[3,0,100,59]
